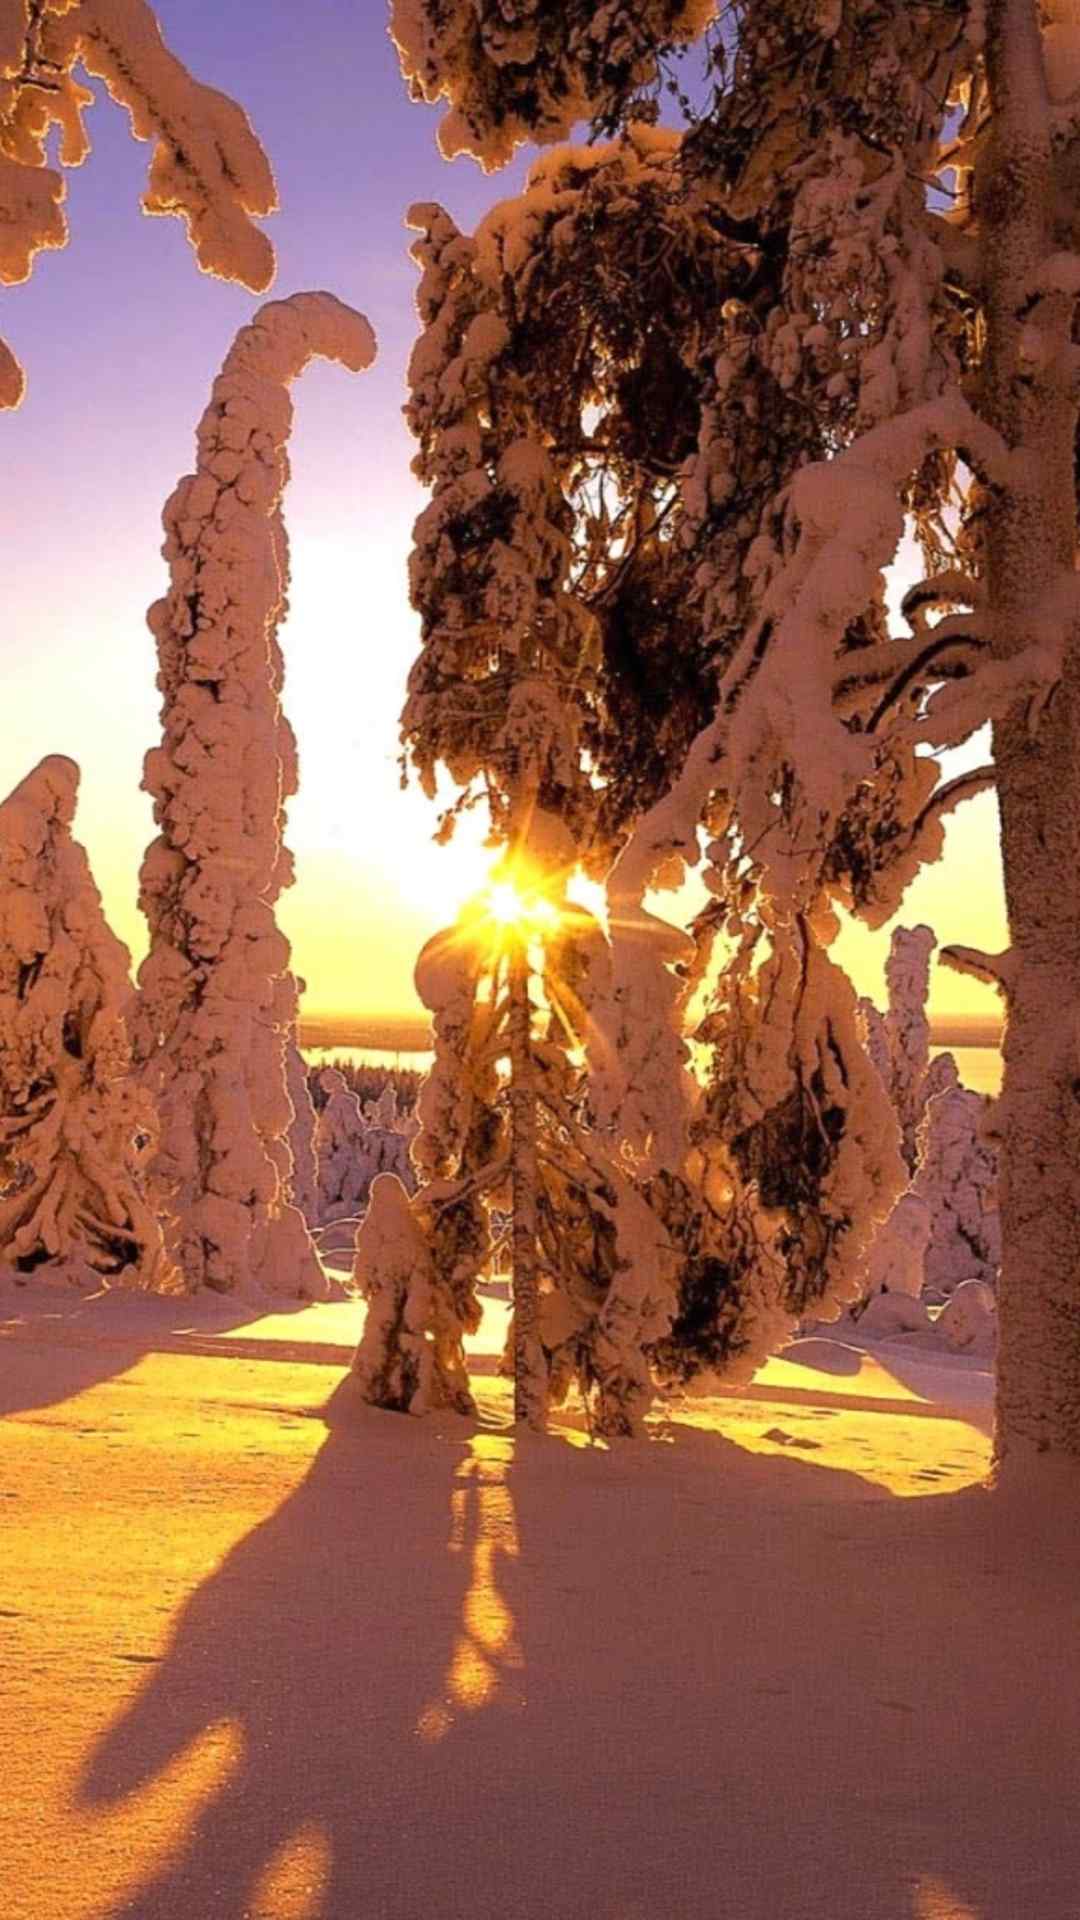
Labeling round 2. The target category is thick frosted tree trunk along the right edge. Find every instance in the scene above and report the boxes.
[976,0,1080,1469]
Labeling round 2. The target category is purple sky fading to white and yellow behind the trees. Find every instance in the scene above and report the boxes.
[0,0,1001,1012]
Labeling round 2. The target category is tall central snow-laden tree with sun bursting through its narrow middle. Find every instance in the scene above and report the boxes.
[349,165,691,1430]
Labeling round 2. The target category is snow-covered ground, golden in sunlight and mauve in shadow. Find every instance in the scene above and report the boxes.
[0,1288,1080,1920]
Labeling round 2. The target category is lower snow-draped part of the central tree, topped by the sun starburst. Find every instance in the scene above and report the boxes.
[356,848,675,1436]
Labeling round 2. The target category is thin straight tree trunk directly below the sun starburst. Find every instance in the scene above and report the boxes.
[507,935,548,1430]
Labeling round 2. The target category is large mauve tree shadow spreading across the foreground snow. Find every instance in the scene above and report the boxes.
[83,1382,1080,1920]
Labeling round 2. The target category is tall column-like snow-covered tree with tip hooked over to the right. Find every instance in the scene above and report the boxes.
[136,294,375,1294]
